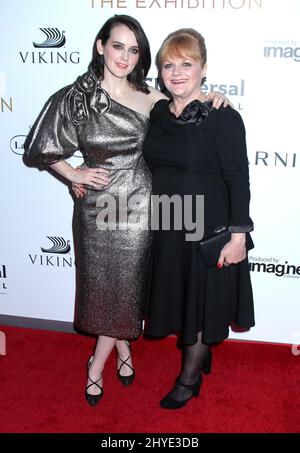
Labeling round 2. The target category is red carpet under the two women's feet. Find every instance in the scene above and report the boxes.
[0,326,300,433]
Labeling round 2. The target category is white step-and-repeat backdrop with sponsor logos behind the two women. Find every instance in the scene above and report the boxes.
[0,0,300,344]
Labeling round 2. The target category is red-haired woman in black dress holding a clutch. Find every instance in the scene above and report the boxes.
[144,29,254,409]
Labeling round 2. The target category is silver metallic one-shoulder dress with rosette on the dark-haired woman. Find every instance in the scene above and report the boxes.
[25,71,151,338]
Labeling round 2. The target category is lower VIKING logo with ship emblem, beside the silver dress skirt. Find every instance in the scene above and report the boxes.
[29,236,73,268]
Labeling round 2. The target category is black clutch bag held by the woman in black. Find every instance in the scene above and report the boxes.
[198,230,254,268]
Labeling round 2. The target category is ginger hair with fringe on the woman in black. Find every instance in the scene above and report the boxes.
[157,28,207,69]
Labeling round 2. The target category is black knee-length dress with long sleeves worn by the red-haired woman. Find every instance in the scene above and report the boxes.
[143,100,254,344]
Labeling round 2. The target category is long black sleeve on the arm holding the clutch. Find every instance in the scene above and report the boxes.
[215,107,253,233]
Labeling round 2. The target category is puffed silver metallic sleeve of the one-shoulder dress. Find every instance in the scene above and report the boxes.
[24,85,79,165]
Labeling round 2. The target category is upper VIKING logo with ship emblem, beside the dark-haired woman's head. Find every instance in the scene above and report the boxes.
[19,28,80,64]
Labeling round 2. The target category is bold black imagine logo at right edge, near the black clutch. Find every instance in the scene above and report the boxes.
[249,256,300,278]
